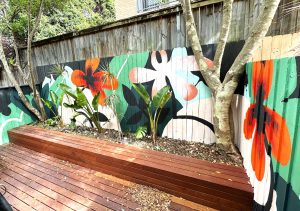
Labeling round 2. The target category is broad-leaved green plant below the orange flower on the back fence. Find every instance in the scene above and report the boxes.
[59,83,102,133]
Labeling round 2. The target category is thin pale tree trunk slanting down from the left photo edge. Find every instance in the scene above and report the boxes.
[0,33,44,121]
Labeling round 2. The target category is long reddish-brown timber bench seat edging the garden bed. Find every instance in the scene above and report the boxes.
[8,126,253,210]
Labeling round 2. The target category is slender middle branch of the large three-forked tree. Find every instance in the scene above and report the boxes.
[214,0,233,77]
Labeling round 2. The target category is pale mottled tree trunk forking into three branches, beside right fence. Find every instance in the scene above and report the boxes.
[181,0,280,153]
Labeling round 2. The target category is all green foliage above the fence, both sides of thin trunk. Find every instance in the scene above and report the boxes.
[0,0,115,42]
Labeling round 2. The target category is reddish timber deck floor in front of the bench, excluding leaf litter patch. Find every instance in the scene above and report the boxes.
[0,144,213,211]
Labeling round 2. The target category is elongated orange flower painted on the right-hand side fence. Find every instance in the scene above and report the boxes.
[244,60,292,181]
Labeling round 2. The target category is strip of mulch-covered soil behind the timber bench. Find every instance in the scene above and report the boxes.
[35,123,243,166]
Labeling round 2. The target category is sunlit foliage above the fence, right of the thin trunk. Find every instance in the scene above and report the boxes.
[35,0,115,40]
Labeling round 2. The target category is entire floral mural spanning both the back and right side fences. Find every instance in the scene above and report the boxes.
[0,37,300,210]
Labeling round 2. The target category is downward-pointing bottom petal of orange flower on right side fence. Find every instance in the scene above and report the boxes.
[251,133,266,181]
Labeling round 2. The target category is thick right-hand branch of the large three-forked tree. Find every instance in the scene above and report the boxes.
[223,0,280,86]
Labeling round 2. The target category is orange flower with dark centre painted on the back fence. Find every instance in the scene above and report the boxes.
[71,58,118,106]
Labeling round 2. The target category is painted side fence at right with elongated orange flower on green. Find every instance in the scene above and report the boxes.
[233,57,300,210]
